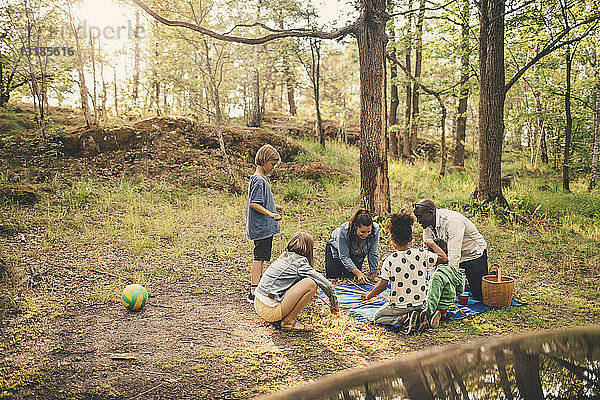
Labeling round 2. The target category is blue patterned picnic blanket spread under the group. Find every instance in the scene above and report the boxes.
[318,283,527,331]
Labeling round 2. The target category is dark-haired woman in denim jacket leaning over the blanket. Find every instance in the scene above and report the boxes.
[325,209,379,283]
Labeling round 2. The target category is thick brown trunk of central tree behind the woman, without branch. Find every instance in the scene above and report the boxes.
[356,0,390,215]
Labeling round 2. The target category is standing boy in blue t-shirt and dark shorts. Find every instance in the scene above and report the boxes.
[246,144,281,304]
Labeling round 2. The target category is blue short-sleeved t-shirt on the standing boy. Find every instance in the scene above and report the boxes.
[246,174,279,240]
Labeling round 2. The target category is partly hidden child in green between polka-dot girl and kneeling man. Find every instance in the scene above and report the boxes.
[427,239,464,328]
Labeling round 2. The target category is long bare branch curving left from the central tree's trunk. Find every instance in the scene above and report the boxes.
[133,0,356,44]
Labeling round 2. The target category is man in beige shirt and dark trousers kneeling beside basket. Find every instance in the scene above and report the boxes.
[414,199,488,300]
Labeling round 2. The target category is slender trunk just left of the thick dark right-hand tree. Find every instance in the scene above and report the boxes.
[453,0,470,167]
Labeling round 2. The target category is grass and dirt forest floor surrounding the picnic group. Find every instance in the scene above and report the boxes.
[0,104,600,399]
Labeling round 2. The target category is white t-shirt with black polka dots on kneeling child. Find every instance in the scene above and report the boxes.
[379,249,438,308]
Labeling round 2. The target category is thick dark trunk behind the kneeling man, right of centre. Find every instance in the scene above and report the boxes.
[473,0,508,206]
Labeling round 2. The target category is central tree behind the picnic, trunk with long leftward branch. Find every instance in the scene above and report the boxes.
[134,0,390,214]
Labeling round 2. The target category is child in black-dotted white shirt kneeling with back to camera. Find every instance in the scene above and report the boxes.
[361,213,448,334]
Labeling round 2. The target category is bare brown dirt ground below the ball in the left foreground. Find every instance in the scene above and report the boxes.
[0,238,364,399]
